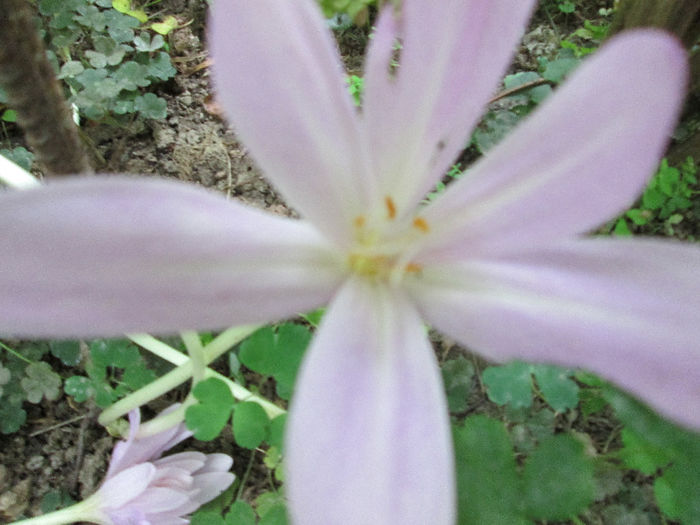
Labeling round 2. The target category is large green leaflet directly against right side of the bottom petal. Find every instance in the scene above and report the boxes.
[453,416,527,525]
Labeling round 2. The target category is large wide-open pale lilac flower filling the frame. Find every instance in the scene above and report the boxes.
[0,0,700,525]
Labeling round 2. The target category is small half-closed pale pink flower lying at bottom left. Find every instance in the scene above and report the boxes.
[13,410,235,525]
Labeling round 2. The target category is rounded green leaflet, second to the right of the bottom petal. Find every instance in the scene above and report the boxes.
[523,435,595,520]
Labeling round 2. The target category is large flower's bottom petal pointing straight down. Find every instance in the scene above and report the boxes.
[286,278,455,525]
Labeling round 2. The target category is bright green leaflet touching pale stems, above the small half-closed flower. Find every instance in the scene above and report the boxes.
[185,377,235,441]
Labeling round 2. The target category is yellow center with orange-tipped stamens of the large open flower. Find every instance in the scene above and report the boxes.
[348,196,430,283]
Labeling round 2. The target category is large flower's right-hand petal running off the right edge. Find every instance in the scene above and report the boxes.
[412,239,700,428]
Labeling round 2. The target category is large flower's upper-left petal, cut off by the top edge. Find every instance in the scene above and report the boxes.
[209,0,373,243]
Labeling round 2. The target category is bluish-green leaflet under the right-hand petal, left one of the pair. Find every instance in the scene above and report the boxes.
[482,361,532,408]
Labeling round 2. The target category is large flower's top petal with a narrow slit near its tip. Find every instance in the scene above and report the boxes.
[363,0,534,217]
